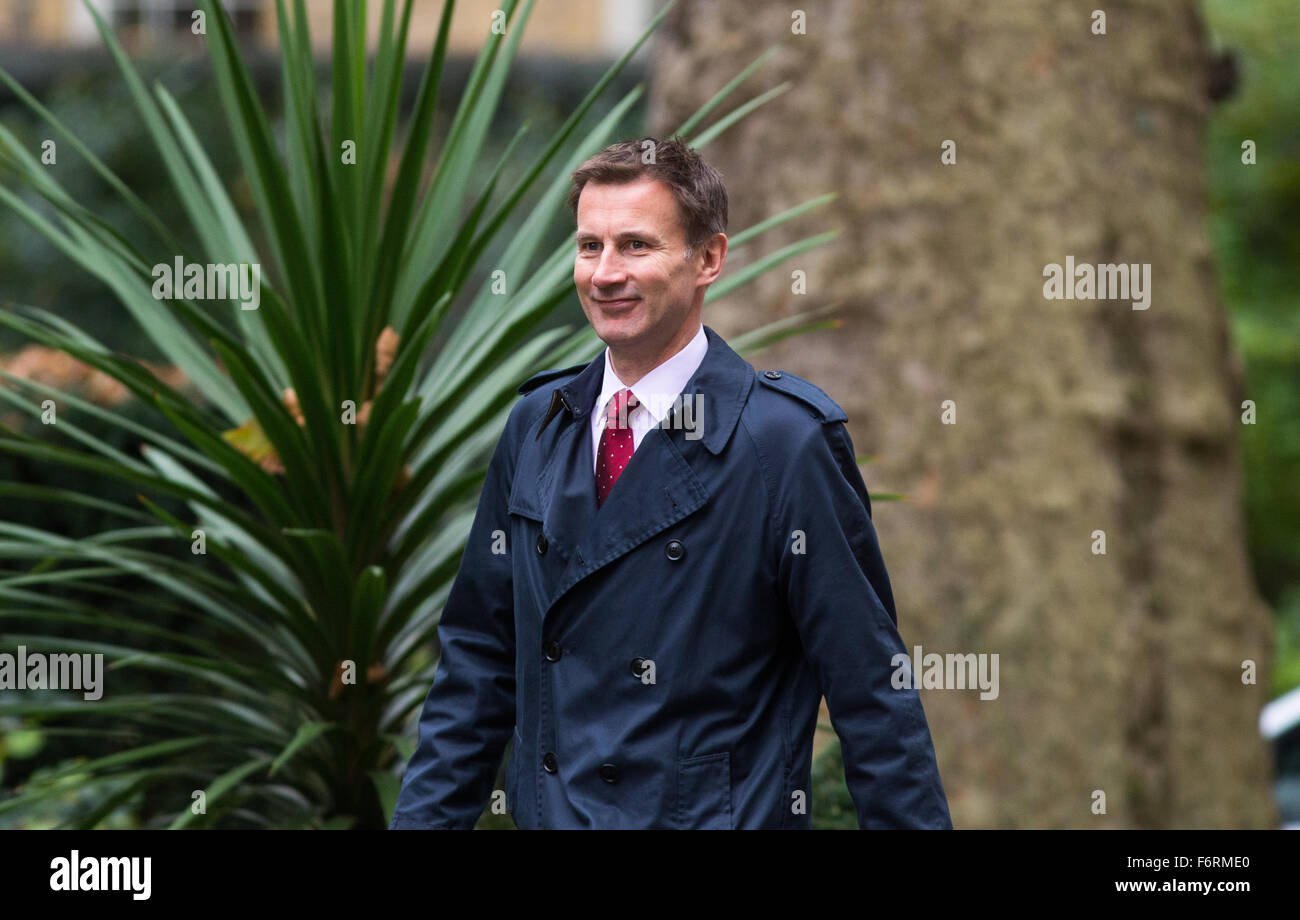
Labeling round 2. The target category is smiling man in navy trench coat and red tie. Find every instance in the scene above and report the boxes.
[391,138,952,829]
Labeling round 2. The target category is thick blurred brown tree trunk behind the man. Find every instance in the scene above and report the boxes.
[651,0,1277,828]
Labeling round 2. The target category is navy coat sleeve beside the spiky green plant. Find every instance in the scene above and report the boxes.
[389,428,515,830]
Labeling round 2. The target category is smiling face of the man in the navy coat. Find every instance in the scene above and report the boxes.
[573,178,712,353]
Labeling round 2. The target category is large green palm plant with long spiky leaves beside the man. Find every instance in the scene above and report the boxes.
[0,0,836,828]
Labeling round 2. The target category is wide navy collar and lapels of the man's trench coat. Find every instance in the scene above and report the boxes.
[520,326,754,626]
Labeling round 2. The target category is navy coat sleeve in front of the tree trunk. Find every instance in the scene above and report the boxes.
[772,421,952,829]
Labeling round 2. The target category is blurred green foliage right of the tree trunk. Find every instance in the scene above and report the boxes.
[1204,0,1300,694]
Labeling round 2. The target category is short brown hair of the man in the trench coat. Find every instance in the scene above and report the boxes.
[568,136,727,259]
